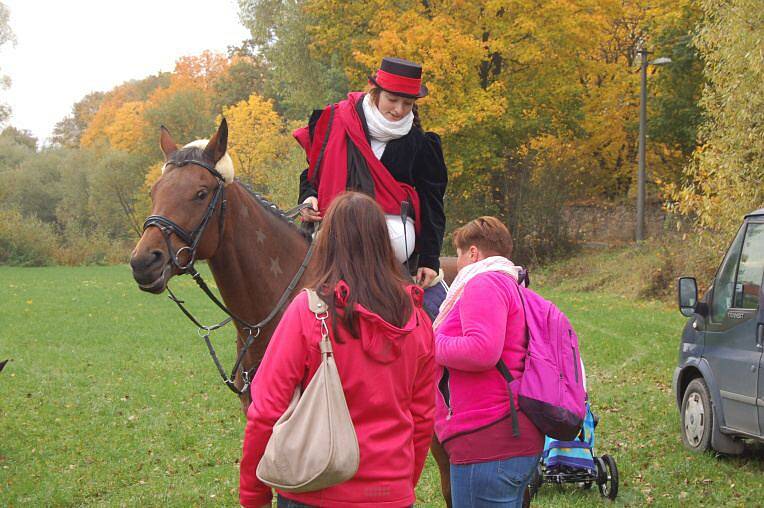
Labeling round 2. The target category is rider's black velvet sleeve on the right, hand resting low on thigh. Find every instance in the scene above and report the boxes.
[413,132,448,272]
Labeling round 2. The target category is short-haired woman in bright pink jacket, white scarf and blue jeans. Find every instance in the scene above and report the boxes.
[434,217,544,508]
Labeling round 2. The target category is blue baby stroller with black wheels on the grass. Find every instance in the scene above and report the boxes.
[529,402,618,500]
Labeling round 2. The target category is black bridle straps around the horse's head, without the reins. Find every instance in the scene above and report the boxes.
[143,160,226,274]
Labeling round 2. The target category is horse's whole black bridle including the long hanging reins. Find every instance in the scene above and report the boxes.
[143,159,314,395]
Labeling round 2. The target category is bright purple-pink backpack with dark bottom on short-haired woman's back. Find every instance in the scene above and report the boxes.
[496,285,586,441]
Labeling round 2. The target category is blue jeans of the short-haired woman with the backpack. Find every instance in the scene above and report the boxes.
[451,455,539,508]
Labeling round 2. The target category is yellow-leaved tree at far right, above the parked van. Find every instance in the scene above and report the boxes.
[675,0,764,239]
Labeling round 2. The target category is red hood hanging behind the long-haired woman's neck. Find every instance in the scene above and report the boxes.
[335,282,429,363]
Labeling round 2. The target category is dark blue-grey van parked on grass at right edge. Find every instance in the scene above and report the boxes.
[672,208,764,455]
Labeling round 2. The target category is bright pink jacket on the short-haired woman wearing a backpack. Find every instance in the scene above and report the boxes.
[435,272,543,452]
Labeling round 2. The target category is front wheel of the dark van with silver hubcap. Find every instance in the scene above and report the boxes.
[682,378,714,452]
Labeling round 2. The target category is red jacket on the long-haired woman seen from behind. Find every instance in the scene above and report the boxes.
[239,286,435,508]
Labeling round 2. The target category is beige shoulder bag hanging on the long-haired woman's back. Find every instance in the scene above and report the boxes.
[257,289,359,492]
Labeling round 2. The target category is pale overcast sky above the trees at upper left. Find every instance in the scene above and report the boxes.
[0,0,249,141]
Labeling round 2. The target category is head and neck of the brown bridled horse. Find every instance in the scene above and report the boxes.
[130,119,310,410]
